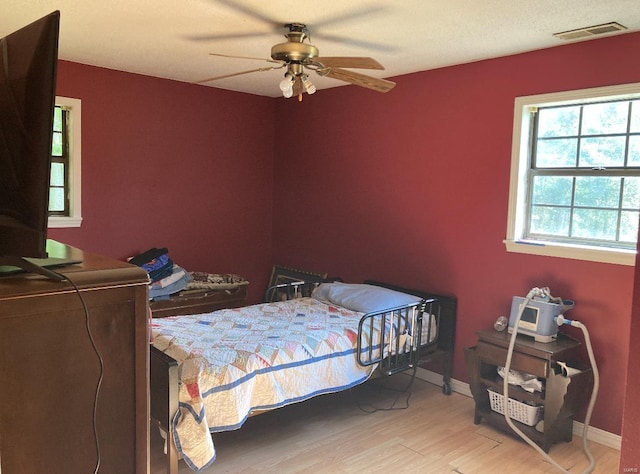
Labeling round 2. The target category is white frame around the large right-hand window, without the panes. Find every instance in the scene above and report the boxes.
[504,83,640,266]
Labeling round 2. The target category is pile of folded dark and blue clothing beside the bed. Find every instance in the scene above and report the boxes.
[129,247,192,300]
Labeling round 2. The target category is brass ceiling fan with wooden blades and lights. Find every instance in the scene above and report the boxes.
[198,23,395,100]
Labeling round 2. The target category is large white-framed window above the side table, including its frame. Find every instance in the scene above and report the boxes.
[505,84,640,265]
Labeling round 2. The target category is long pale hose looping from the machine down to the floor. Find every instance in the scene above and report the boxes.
[502,288,600,474]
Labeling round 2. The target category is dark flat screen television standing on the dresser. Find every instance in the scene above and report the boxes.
[0,11,70,278]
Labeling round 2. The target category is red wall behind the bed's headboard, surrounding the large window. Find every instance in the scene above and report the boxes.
[273,34,640,433]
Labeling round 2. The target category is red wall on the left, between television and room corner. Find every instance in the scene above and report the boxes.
[49,61,274,301]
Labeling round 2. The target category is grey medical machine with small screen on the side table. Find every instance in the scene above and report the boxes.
[509,294,575,342]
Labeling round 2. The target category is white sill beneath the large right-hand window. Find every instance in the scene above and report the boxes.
[504,240,636,266]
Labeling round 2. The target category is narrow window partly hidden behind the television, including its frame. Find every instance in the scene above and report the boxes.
[49,97,82,228]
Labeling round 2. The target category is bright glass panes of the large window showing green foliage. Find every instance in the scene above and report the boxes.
[526,100,640,248]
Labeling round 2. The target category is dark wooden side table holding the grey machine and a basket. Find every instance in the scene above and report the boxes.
[465,330,593,452]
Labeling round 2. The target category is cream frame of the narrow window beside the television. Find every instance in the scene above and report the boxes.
[48,96,82,229]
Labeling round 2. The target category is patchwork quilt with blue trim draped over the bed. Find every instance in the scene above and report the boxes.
[152,298,375,471]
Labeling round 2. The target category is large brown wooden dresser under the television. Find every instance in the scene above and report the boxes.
[0,243,149,474]
